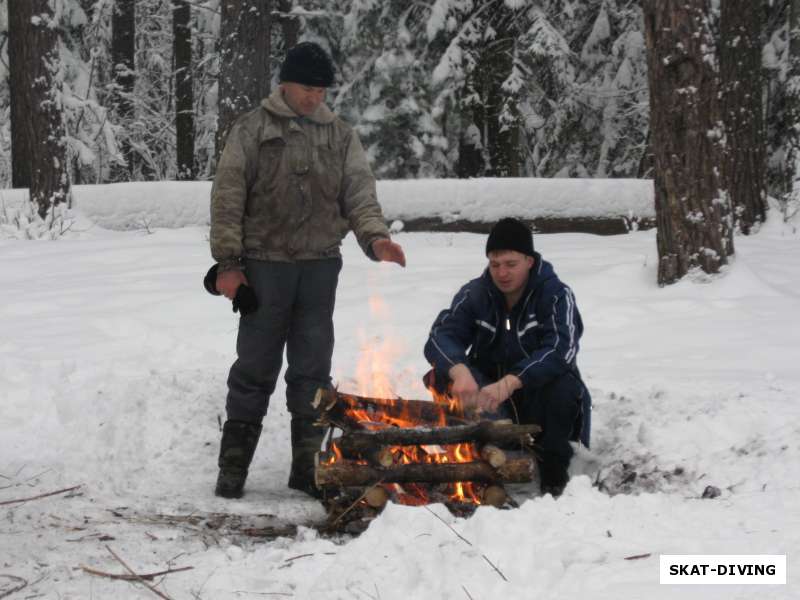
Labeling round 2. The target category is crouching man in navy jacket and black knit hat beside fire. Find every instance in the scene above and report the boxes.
[425,219,591,496]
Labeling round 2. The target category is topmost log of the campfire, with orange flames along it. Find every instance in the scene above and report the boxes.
[313,388,469,429]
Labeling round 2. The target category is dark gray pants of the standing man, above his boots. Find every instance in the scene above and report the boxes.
[226,258,342,423]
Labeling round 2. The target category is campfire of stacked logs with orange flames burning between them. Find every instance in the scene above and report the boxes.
[315,389,539,528]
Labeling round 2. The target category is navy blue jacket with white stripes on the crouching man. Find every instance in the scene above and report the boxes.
[425,253,583,388]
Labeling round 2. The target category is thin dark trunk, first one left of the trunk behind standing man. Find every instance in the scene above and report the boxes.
[172,0,195,180]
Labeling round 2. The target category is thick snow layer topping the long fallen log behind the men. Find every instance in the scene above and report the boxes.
[0,178,655,230]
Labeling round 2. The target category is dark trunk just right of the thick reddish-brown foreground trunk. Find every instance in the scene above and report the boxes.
[719,0,767,234]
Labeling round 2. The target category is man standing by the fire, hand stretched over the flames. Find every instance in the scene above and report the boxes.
[211,42,405,498]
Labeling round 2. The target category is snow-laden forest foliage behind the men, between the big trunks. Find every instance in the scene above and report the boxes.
[0,0,797,190]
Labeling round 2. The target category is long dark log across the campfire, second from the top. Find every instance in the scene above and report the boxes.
[335,420,541,458]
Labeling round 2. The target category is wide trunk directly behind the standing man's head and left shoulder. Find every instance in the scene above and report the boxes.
[216,0,272,158]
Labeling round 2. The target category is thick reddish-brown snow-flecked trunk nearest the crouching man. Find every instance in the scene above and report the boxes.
[644,0,733,285]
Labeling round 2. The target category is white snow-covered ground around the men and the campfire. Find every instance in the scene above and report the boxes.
[0,198,800,600]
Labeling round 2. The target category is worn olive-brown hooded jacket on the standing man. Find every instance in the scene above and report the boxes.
[210,89,389,271]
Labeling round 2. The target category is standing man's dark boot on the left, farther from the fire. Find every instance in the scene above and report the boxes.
[214,421,261,498]
